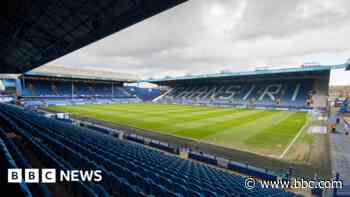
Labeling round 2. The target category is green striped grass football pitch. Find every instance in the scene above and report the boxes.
[50,104,307,156]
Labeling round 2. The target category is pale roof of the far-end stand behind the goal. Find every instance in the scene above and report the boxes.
[23,65,139,82]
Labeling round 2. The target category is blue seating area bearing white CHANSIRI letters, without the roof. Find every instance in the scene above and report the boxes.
[157,80,313,108]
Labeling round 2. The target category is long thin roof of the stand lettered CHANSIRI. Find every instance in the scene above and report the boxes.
[144,64,348,85]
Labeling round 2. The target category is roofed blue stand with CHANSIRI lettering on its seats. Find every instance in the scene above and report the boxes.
[148,65,344,111]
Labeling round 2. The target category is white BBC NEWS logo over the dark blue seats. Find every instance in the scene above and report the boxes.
[7,168,102,183]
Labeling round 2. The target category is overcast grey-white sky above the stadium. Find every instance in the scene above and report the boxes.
[50,0,350,84]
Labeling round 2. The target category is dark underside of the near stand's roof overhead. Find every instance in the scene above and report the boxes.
[0,0,187,73]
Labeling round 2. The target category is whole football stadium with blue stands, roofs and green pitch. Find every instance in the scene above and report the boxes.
[0,0,350,197]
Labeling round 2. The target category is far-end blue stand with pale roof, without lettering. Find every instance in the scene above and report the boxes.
[17,65,140,107]
